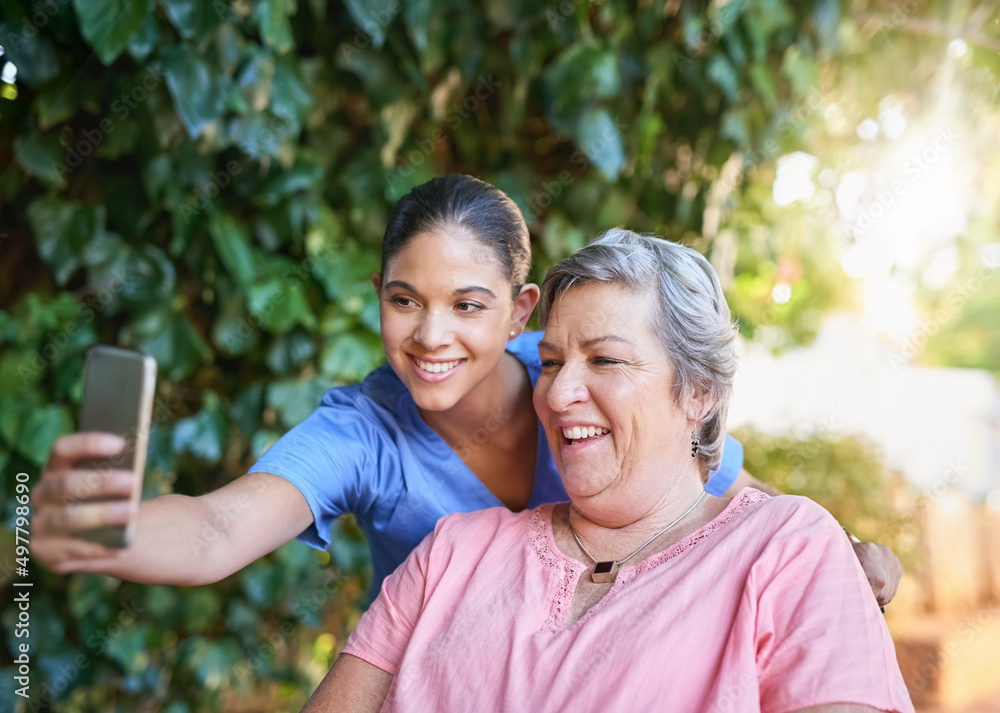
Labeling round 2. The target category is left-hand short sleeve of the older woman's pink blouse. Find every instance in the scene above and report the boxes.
[344,530,436,676]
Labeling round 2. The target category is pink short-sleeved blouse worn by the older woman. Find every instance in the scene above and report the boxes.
[344,488,913,713]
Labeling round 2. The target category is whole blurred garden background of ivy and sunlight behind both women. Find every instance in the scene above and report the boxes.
[0,0,1000,713]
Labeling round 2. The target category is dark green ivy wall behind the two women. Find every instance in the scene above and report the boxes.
[0,0,992,713]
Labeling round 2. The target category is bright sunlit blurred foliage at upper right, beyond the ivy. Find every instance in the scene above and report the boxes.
[736,0,1000,358]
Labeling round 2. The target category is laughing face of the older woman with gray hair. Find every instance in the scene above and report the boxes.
[534,282,696,510]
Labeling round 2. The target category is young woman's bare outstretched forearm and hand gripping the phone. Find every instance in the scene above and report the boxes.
[31,433,313,586]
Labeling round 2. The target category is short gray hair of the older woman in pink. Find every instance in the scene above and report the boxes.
[539,228,737,480]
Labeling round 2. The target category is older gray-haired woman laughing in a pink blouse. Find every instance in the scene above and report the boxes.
[306,230,913,712]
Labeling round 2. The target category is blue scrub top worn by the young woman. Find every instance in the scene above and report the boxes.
[249,332,743,599]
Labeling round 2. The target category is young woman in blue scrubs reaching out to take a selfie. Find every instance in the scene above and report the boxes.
[32,176,898,598]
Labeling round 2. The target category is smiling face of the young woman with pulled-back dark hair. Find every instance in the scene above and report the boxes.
[373,231,516,411]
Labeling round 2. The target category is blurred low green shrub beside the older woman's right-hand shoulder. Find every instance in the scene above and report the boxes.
[732,427,918,568]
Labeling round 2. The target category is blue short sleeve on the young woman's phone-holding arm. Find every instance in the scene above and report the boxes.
[248,387,400,549]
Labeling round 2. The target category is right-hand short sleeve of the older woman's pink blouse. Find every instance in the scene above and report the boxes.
[747,496,913,713]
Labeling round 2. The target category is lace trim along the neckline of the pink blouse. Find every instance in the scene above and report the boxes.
[528,488,770,631]
